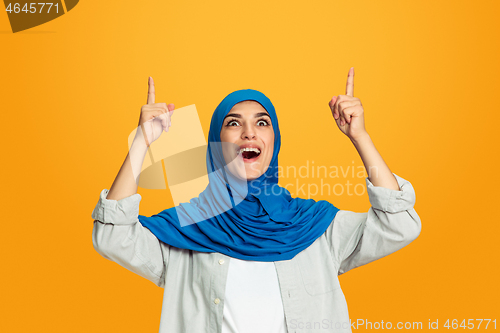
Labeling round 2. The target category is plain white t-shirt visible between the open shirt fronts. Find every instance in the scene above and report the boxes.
[222,258,287,333]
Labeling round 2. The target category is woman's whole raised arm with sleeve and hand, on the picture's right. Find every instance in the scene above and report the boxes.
[326,67,421,274]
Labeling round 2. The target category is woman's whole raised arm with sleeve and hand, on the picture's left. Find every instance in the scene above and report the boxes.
[92,78,174,287]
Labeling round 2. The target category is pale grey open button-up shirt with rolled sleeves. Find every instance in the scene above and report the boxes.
[92,174,421,333]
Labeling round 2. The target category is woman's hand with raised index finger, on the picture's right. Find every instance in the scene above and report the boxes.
[328,67,368,140]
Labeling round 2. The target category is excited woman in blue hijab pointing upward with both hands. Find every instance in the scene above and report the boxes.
[92,68,421,333]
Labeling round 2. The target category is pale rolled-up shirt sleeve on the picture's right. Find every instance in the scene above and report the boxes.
[326,173,421,275]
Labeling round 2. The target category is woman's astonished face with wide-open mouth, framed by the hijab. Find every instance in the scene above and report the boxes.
[220,101,274,180]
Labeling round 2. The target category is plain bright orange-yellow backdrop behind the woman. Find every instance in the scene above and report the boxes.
[0,0,500,333]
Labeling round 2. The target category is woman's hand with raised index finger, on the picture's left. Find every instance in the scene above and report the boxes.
[135,77,175,147]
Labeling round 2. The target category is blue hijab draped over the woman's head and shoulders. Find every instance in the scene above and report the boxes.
[139,89,339,261]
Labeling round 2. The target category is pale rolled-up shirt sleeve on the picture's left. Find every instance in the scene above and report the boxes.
[92,189,170,288]
